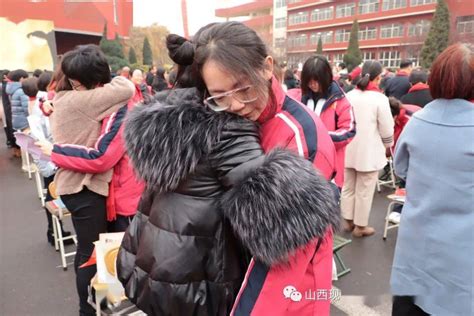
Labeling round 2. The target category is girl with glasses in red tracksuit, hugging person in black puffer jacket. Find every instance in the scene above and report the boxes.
[187,22,339,315]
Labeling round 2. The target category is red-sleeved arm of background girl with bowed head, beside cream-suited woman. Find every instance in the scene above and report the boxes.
[329,98,356,149]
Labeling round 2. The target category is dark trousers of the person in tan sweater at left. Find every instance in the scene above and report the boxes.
[61,188,107,316]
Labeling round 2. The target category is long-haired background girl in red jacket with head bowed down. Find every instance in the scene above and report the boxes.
[287,55,356,188]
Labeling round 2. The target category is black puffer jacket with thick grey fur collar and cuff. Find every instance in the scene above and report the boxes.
[117,89,340,316]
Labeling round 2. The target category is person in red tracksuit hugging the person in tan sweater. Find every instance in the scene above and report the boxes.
[37,101,144,232]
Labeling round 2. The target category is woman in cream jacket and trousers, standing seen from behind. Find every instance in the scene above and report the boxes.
[341,61,394,237]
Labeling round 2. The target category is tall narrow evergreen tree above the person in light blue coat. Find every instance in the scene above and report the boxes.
[420,0,450,69]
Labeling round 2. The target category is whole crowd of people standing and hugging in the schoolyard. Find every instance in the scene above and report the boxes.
[2,22,474,315]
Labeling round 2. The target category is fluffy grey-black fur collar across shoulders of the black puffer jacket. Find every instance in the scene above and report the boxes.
[124,88,238,192]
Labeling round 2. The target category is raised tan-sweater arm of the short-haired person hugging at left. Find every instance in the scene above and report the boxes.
[74,76,135,121]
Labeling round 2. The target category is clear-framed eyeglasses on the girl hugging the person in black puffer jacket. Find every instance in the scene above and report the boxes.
[204,85,258,112]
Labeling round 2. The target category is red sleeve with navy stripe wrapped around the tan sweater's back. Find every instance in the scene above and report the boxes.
[51,106,127,173]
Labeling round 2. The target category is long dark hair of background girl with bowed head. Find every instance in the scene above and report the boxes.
[301,55,332,95]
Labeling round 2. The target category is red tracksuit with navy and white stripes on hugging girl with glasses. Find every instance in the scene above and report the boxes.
[231,78,336,316]
